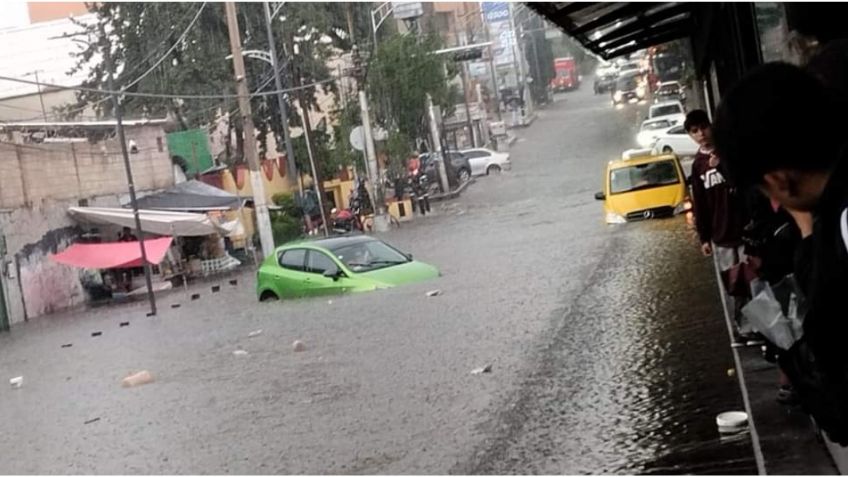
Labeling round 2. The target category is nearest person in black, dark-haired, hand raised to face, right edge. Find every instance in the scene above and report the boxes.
[716,63,848,446]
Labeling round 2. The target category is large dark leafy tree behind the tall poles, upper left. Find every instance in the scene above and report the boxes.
[62,2,370,163]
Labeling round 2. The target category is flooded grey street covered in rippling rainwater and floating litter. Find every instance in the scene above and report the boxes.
[0,88,756,474]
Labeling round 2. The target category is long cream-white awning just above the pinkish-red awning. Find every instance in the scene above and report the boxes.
[68,207,232,237]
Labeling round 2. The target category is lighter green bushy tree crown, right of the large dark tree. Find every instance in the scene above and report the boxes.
[368,34,456,138]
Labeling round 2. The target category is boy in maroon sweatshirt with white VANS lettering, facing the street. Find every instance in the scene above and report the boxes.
[683,109,752,343]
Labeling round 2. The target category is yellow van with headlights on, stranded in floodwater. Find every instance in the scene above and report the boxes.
[595,150,691,224]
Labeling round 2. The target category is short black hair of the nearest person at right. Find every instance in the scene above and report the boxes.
[713,63,848,187]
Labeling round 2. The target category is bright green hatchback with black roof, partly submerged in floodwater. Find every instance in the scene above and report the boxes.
[256,235,439,301]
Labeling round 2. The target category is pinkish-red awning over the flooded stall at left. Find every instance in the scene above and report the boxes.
[50,237,174,269]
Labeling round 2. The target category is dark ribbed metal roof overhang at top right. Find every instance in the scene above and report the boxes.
[526,2,693,60]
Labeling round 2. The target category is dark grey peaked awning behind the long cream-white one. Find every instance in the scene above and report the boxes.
[130,180,240,211]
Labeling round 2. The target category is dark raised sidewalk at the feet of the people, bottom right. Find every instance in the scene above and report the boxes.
[716,256,840,475]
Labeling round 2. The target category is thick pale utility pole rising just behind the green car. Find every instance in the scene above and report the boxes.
[224,2,274,257]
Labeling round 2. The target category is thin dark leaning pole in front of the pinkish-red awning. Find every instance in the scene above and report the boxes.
[99,23,156,316]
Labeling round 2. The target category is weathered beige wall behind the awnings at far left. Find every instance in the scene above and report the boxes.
[0,126,174,323]
